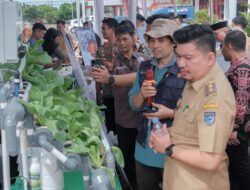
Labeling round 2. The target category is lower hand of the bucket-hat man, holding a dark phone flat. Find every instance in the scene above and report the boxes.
[143,103,174,119]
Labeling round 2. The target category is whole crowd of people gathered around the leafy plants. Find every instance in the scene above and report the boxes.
[22,14,250,190]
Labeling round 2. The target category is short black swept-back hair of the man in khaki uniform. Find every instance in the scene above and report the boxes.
[173,24,216,53]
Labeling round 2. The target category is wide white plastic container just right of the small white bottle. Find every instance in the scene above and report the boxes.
[41,151,64,190]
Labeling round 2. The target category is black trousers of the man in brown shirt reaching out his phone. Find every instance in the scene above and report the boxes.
[116,125,137,190]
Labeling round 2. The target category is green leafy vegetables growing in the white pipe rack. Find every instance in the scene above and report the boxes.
[1,40,124,189]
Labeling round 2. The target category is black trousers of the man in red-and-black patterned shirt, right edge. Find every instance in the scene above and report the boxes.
[226,140,250,190]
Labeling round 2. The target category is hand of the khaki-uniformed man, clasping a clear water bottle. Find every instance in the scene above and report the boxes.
[149,124,172,154]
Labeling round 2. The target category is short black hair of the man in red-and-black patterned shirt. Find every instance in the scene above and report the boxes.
[224,30,247,52]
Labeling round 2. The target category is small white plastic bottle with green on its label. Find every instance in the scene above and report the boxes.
[29,157,41,190]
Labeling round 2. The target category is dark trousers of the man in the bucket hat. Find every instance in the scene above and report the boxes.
[136,161,163,190]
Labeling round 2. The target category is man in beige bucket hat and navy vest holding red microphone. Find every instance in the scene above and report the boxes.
[129,18,185,190]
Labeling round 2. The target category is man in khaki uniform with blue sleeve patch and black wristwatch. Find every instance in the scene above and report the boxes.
[150,25,235,190]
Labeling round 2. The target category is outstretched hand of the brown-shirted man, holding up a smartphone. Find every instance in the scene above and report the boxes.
[90,66,109,84]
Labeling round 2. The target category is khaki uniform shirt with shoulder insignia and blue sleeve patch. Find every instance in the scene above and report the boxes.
[163,64,236,190]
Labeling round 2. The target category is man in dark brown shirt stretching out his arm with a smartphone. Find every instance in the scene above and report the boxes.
[91,25,149,190]
